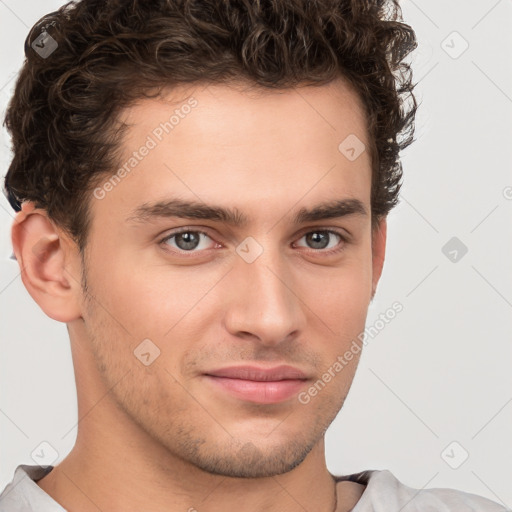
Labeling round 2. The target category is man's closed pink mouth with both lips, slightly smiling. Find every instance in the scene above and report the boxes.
[203,365,308,404]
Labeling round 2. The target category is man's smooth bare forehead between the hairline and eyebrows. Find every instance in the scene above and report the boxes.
[89,80,371,231]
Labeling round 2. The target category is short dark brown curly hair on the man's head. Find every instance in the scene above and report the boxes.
[4,0,417,252]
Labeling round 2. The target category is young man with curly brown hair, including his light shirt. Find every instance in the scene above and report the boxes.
[0,0,504,512]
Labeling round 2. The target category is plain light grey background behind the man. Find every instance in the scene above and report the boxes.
[0,0,512,507]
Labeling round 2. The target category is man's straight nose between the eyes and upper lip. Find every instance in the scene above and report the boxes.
[224,243,305,346]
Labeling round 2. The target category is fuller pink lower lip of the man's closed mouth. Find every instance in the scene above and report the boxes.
[206,375,305,404]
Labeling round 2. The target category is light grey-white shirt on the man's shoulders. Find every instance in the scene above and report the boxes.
[0,464,510,512]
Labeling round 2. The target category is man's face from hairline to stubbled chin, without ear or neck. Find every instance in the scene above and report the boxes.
[75,81,383,477]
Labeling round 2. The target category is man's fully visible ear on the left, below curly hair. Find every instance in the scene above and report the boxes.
[11,202,81,322]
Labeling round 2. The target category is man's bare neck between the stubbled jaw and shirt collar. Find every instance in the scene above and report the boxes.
[38,418,336,512]
